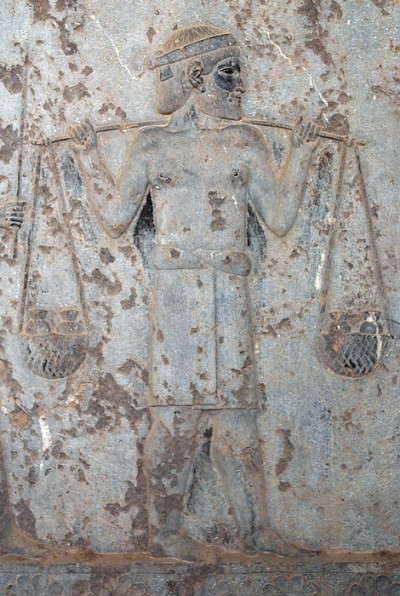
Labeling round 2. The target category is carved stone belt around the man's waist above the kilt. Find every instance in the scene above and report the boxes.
[153,246,251,276]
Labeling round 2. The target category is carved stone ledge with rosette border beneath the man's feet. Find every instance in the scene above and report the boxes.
[0,563,400,596]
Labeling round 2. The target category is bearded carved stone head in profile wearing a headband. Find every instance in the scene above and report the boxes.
[149,25,244,120]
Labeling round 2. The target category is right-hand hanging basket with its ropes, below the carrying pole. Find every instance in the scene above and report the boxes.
[319,143,390,378]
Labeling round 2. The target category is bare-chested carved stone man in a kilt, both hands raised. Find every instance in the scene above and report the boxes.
[72,26,317,558]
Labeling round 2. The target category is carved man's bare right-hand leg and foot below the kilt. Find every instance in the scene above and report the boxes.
[211,409,299,556]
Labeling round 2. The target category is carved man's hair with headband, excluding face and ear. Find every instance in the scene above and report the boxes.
[148,25,239,114]
